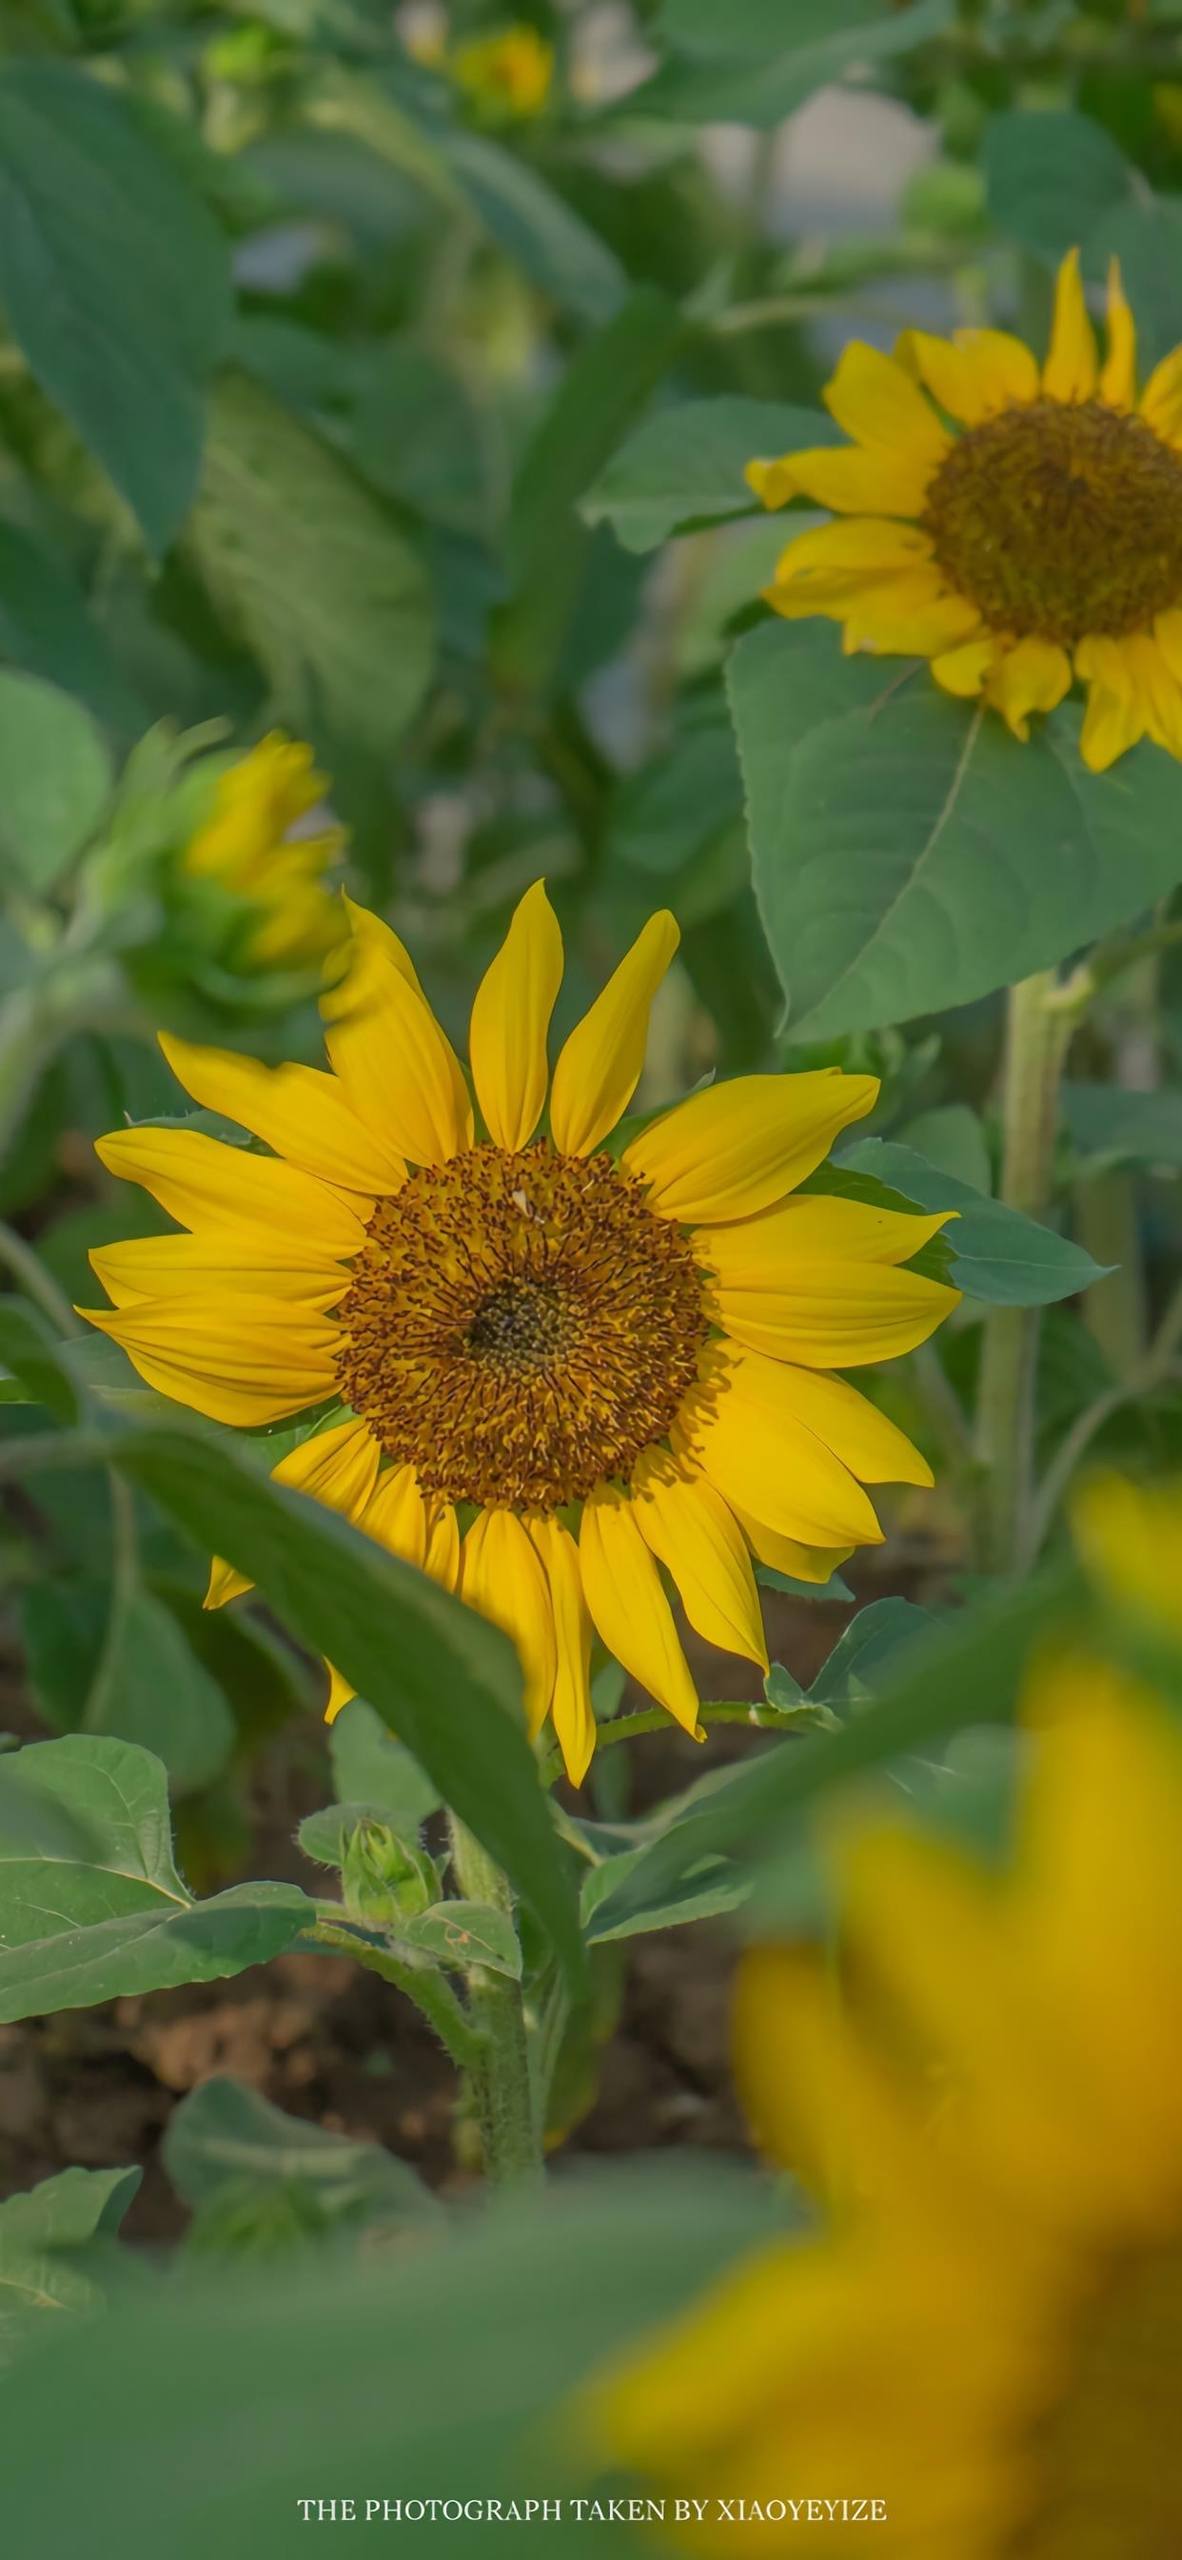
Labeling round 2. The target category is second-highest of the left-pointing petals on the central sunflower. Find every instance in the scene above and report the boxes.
[95,1129,366,1277]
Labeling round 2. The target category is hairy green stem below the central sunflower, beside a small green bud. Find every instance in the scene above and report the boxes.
[448,1812,542,2186]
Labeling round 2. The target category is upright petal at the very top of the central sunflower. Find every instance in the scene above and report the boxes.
[468,881,563,1155]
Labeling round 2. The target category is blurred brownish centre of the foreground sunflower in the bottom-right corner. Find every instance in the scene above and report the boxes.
[1005,2240,1182,2560]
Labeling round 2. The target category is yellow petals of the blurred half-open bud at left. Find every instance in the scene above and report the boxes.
[182,730,345,970]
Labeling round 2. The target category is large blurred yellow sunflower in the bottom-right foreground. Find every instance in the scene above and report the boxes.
[594,1661,1182,2560]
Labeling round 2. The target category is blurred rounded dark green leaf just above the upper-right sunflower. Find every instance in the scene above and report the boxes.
[982,108,1139,264]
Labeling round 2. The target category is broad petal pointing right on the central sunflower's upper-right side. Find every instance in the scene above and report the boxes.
[622,1068,878,1224]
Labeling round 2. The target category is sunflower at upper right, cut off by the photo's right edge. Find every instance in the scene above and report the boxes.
[747,248,1182,773]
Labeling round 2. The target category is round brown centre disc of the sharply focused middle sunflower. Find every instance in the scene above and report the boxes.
[338,1144,709,1510]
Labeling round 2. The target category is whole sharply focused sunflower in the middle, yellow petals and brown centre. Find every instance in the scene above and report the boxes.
[80,881,957,1779]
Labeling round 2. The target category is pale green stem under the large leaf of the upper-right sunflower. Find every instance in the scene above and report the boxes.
[977,970,1072,1572]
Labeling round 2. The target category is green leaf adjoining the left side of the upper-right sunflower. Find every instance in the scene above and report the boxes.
[583,397,839,550]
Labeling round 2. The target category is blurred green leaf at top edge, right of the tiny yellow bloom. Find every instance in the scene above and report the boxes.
[627,0,954,128]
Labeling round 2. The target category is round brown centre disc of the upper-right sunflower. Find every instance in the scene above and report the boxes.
[921,399,1182,648]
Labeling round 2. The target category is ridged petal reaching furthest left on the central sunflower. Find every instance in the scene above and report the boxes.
[82,1290,340,1428]
